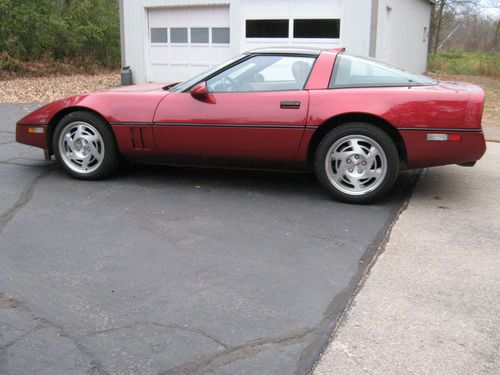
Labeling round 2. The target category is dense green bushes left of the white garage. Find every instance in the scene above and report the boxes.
[0,0,120,70]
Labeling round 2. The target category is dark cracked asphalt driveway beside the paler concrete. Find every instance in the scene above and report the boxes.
[0,105,411,374]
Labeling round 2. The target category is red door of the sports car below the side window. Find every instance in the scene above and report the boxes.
[150,90,309,163]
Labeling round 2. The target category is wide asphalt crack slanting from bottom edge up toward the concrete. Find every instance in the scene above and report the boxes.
[160,328,315,375]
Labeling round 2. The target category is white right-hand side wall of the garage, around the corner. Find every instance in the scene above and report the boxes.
[375,0,431,73]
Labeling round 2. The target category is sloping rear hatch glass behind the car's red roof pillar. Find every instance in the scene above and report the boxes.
[330,54,438,88]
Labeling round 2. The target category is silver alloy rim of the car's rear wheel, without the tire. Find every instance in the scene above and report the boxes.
[325,135,387,196]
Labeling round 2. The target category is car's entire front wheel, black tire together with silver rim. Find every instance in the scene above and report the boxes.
[52,111,120,180]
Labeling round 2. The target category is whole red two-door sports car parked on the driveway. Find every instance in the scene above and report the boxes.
[16,48,486,203]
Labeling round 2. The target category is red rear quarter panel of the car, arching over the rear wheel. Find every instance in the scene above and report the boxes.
[298,85,485,168]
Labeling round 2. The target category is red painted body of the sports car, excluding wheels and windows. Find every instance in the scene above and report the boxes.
[16,50,486,168]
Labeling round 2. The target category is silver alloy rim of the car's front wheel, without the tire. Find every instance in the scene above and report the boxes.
[58,121,105,174]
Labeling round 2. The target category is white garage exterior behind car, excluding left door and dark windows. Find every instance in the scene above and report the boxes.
[123,0,430,83]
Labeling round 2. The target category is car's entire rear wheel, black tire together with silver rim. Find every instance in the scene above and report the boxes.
[314,122,399,204]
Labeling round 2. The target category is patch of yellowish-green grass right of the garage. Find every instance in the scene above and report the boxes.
[429,50,500,78]
